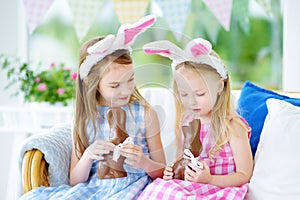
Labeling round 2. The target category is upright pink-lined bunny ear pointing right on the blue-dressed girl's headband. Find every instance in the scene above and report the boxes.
[118,15,156,46]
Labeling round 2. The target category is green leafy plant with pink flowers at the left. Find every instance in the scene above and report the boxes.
[0,54,77,106]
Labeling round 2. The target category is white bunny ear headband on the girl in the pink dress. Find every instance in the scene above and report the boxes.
[143,38,227,79]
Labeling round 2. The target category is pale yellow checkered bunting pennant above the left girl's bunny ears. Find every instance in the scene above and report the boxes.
[113,0,150,24]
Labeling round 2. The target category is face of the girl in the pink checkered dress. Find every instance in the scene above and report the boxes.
[175,67,221,122]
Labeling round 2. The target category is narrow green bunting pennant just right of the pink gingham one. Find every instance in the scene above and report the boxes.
[232,0,250,34]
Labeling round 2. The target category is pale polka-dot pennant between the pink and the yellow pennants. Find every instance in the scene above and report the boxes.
[68,0,103,42]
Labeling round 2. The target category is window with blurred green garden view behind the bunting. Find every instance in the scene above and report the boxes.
[28,0,283,89]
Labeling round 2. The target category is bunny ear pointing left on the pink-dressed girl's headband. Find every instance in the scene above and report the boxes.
[143,40,183,60]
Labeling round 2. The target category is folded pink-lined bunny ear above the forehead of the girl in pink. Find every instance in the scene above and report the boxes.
[184,38,212,58]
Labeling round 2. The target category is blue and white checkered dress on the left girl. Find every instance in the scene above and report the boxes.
[20,103,151,200]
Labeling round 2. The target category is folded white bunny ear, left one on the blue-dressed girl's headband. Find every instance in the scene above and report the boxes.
[87,35,115,54]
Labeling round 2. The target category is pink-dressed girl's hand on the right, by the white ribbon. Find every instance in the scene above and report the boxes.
[184,161,212,184]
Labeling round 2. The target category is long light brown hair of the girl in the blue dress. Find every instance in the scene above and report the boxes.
[73,37,149,158]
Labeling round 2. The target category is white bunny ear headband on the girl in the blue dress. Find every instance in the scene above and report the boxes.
[79,15,156,80]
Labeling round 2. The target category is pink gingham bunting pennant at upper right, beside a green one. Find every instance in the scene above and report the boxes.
[203,0,232,31]
